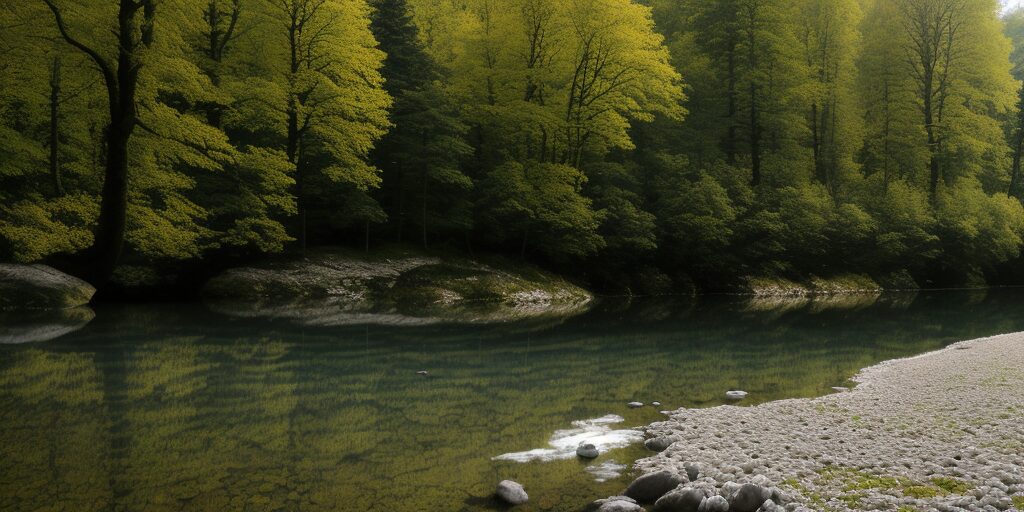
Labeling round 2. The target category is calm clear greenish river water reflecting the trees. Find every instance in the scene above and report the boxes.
[0,290,1024,512]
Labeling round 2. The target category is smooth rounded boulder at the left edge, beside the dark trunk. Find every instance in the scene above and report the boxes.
[0,263,96,310]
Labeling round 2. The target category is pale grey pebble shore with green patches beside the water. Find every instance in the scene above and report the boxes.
[636,333,1024,512]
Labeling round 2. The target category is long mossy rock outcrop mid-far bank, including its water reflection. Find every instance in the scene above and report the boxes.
[203,250,592,326]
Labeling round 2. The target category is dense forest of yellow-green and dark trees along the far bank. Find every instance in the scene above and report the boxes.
[0,0,1024,293]
